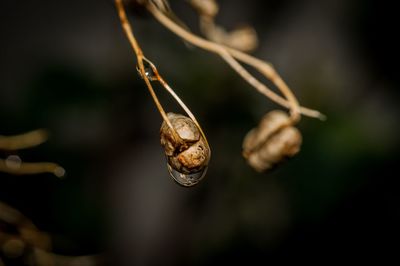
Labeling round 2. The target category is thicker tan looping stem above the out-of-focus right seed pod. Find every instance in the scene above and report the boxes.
[147,1,324,120]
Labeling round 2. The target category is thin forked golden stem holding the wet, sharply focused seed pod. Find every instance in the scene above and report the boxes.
[115,0,207,145]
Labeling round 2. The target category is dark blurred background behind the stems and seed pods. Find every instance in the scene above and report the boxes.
[0,0,400,265]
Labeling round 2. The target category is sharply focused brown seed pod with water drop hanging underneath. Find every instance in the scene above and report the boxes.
[160,113,211,187]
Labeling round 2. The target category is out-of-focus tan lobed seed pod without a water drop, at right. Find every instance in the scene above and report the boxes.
[243,110,302,172]
